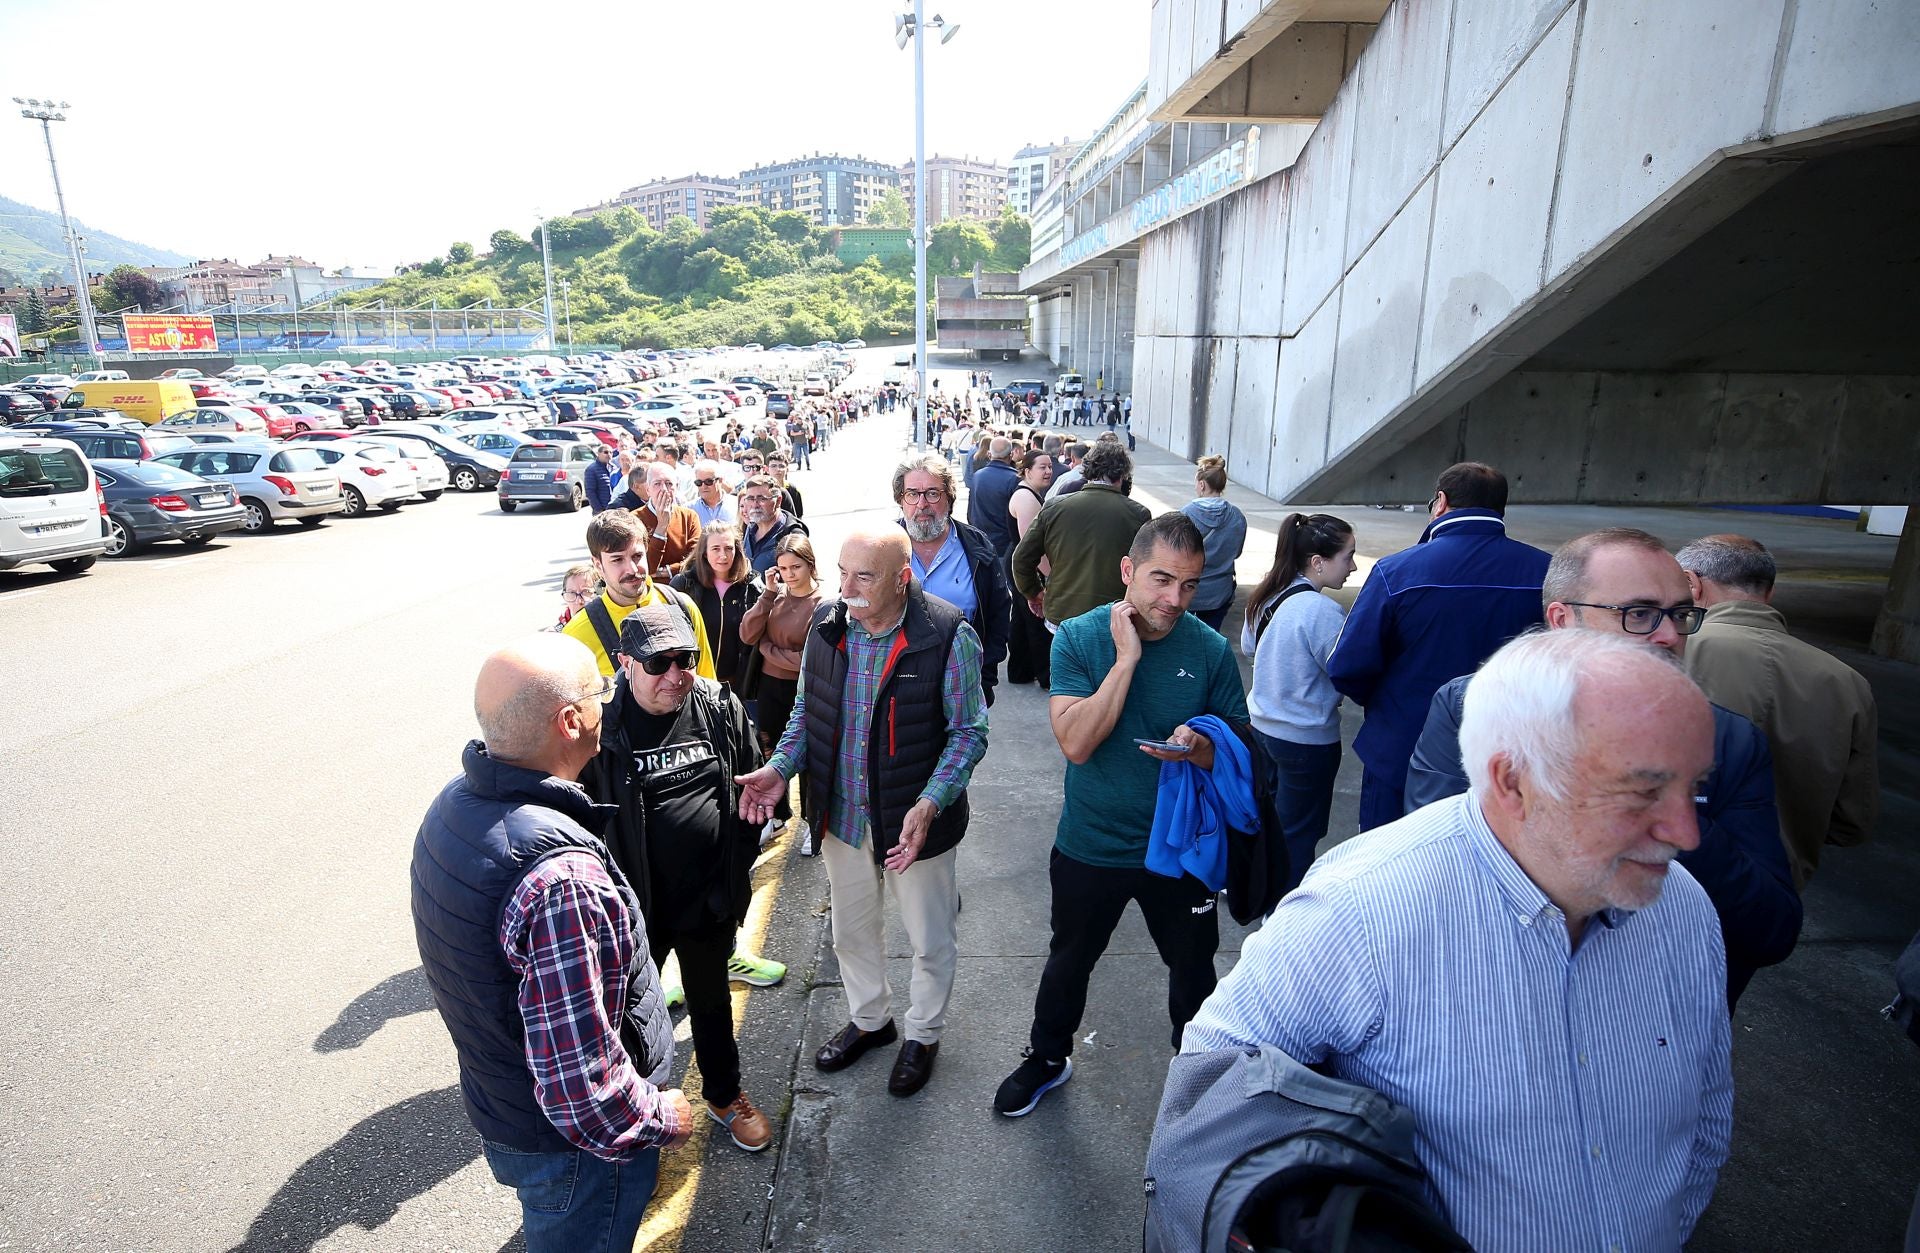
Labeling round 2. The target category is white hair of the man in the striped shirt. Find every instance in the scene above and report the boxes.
[1459,629,1684,800]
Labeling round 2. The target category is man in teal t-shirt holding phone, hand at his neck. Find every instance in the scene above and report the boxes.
[993,514,1246,1119]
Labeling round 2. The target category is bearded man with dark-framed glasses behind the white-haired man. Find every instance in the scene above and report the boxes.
[1405,526,1801,1009]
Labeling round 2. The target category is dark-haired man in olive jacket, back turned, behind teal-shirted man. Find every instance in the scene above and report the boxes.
[1014,439,1152,629]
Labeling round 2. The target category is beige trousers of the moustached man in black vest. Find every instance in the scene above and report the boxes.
[820,835,960,1044]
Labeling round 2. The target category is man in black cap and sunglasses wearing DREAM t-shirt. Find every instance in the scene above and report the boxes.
[582,604,774,1153]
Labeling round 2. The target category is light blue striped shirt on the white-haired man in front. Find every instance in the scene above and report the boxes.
[1183,794,1734,1253]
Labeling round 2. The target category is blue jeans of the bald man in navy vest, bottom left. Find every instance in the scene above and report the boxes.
[480,1140,660,1253]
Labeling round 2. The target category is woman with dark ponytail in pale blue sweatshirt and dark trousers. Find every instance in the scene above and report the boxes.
[1240,514,1354,890]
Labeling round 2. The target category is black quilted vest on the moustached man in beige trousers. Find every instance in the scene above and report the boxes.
[801,579,968,862]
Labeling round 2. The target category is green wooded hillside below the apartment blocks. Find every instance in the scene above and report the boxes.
[342,205,1029,347]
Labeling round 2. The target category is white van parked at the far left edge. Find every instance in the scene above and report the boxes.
[0,436,108,574]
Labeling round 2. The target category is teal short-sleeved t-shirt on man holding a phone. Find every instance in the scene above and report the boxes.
[1052,604,1246,869]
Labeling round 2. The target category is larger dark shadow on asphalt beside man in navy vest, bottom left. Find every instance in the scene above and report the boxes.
[230,1084,483,1253]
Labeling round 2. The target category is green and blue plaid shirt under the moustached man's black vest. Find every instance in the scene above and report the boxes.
[768,614,987,848]
